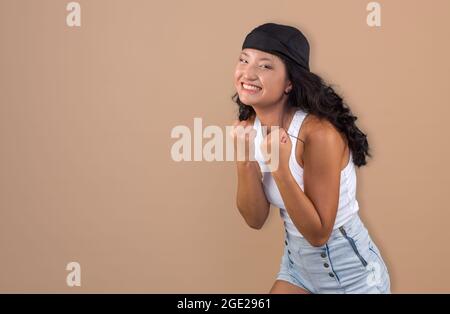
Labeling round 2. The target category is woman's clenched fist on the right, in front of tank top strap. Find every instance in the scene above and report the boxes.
[261,127,292,175]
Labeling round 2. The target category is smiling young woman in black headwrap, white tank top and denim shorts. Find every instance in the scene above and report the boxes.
[232,23,390,293]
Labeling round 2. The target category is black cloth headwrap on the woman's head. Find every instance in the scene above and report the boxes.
[242,23,309,71]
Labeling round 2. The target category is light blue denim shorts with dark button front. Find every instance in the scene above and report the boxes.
[277,213,391,294]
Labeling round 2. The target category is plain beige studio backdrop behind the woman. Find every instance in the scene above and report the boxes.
[0,0,450,293]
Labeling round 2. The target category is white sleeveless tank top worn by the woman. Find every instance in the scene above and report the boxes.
[253,109,359,236]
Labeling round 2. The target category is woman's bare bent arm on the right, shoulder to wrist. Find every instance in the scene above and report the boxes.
[272,126,345,246]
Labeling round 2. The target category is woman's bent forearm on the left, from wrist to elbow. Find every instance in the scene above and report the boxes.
[236,161,270,229]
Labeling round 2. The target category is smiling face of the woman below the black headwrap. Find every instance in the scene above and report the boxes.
[234,48,292,106]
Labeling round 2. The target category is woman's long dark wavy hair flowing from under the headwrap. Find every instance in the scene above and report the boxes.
[232,52,372,167]
